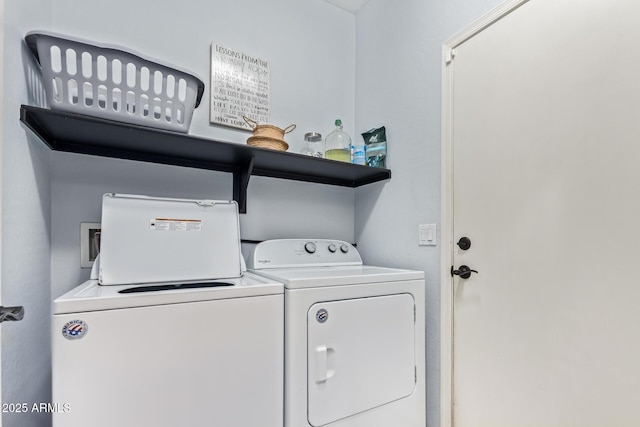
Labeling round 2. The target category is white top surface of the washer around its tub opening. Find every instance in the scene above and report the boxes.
[53,273,284,315]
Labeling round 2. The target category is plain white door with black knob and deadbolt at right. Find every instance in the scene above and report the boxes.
[442,0,640,427]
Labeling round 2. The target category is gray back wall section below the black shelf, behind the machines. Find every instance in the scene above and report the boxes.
[51,152,354,298]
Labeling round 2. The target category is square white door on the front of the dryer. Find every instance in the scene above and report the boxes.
[307,294,415,427]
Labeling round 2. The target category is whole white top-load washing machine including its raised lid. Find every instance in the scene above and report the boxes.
[52,194,284,427]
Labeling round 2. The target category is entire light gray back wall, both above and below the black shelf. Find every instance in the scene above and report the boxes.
[52,0,355,298]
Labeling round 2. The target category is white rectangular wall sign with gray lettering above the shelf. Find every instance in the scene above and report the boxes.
[209,43,269,130]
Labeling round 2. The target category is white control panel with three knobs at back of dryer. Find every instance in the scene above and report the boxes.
[248,239,362,269]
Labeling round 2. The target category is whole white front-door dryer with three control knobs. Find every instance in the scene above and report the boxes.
[248,239,426,427]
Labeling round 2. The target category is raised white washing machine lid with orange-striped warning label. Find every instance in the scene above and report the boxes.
[99,193,242,285]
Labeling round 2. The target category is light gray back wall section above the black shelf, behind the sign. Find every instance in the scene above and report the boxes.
[50,0,355,148]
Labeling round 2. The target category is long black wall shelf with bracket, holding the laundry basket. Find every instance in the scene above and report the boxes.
[20,105,391,213]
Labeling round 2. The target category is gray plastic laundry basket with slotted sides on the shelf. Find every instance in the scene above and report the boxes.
[25,31,204,133]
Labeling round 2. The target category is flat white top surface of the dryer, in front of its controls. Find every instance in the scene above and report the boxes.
[254,265,424,289]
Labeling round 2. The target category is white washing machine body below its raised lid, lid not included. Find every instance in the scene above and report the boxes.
[52,273,284,427]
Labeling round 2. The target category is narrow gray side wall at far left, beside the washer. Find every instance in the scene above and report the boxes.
[0,0,51,427]
